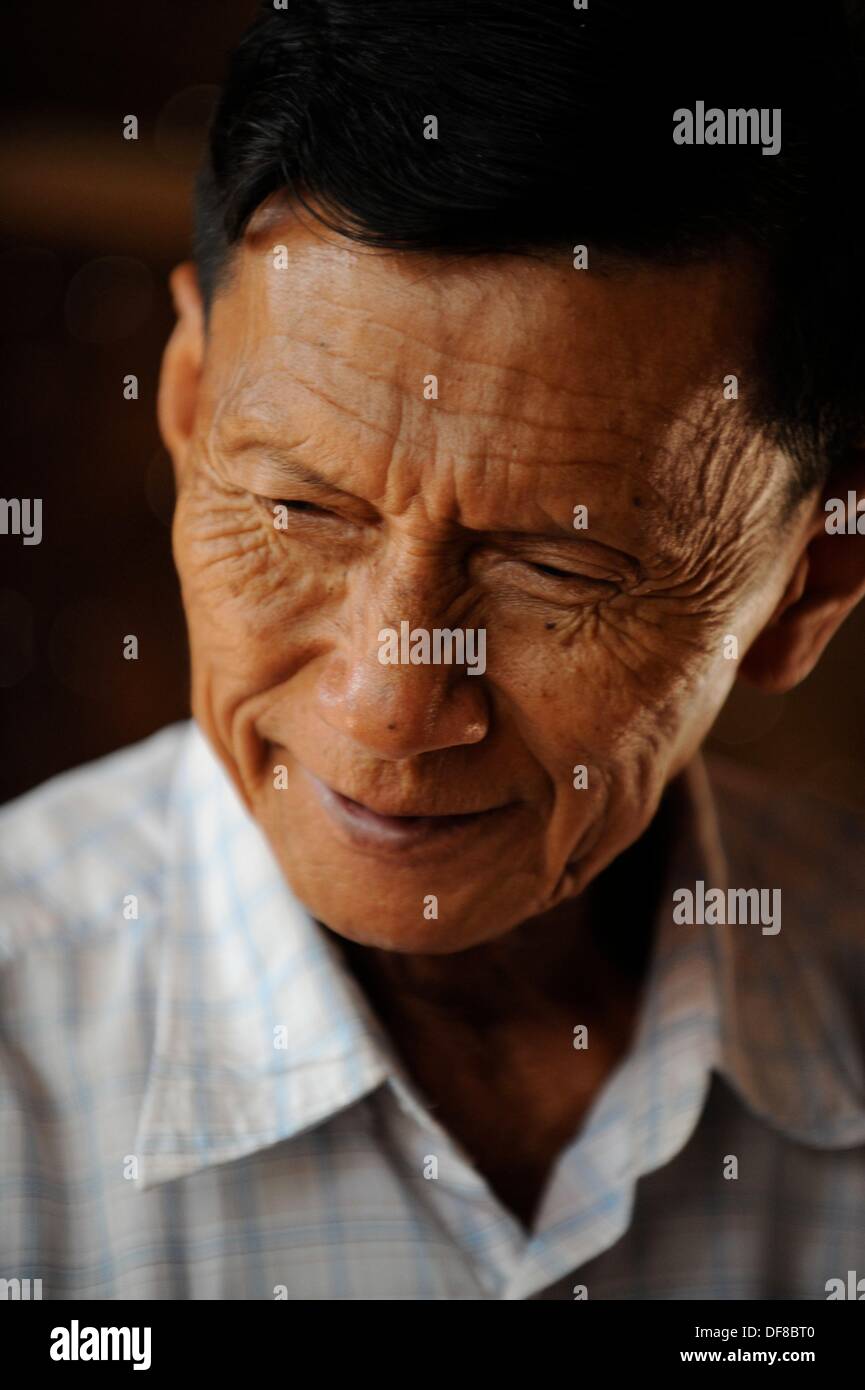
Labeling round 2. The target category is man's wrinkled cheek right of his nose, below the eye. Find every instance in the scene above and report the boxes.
[489,603,731,865]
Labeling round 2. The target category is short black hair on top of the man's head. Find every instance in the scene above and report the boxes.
[195,0,865,498]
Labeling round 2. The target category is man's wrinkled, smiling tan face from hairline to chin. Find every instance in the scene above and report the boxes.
[166,208,817,954]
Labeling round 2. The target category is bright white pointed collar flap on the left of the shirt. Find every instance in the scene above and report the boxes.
[134,721,394,1187]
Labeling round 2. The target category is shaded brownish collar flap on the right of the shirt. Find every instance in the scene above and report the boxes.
[678,758,865,1148]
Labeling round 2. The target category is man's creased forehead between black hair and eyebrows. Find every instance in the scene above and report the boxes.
[204,202,759,533]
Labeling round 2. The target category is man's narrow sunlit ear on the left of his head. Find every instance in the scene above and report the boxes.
[156,261,204,478]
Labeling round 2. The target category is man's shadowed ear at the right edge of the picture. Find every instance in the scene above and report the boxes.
[740,448,865,694]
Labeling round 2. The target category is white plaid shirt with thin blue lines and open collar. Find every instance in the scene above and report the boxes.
[0,723,865,1300]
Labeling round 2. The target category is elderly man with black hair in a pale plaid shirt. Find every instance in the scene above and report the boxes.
[0,0,865,1300]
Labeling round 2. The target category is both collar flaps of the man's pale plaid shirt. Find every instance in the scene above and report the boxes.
[134,721,865,1187]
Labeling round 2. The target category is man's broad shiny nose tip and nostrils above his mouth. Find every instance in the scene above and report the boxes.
[316,594,490,762]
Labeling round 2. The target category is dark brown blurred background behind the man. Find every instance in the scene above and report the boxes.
[0,0,865,810]
